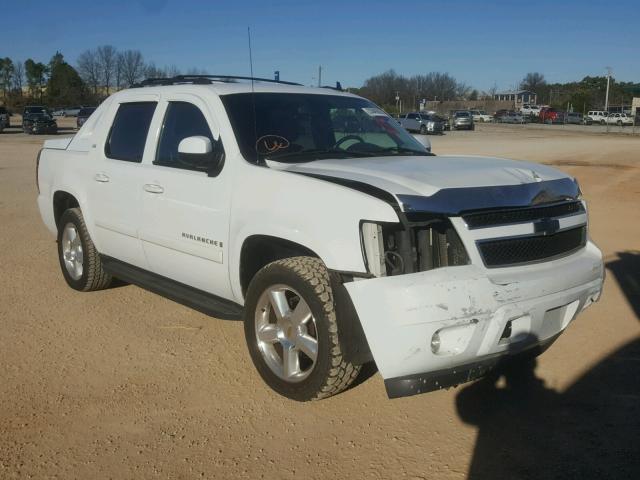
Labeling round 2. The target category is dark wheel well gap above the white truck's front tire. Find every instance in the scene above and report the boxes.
[240,235,318,295]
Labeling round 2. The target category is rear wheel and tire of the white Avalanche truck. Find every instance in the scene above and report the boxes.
[58,208,112,292]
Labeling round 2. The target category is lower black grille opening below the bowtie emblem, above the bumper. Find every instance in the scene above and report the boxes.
[478,226,587,268]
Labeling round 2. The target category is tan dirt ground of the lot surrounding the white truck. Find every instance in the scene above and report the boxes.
[0,120,640,479]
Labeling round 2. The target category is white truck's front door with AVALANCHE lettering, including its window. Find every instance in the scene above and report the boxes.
[140,94,232,298]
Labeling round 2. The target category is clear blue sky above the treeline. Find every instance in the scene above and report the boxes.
[0,0,640,91]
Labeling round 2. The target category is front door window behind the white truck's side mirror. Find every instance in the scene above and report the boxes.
[153,102,215,170]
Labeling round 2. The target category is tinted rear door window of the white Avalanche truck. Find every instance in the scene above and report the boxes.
[104,102,157,163]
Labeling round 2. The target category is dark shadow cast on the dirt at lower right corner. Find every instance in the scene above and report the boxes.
[456,252,640,480]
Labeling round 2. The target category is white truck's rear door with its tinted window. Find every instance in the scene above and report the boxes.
[87,99,158,268]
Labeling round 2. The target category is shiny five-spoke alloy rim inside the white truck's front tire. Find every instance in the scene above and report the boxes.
[255,284,318,382]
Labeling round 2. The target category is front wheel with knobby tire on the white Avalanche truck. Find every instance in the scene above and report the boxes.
[244,257,361,401]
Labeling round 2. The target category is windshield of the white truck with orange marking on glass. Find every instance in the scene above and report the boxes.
[220,93,431,163]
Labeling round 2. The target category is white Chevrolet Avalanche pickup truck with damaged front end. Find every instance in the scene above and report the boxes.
[37,76,604,400]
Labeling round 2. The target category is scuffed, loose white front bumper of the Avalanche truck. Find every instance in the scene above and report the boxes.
[345,242,604,398]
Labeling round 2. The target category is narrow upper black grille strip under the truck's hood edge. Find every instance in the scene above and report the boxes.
[462,201,584,228]
